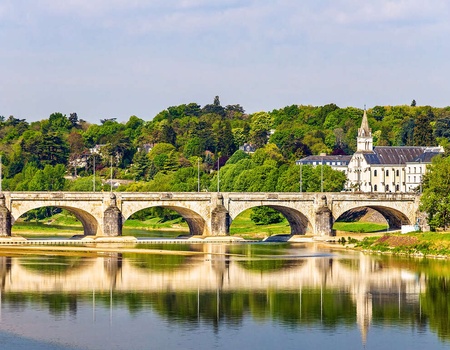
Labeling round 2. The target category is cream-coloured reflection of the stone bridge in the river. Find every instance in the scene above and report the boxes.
[0,252,424,294]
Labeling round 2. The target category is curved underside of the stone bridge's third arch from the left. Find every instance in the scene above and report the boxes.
[230,202,313,235]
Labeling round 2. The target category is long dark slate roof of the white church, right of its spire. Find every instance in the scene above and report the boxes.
[363,146,440,164]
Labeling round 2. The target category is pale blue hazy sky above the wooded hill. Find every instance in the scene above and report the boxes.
[0,0,450,123]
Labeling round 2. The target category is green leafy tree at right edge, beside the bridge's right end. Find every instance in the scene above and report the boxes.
[419,156,450,230]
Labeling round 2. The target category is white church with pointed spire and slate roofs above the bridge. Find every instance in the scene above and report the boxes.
[297,110,443,193]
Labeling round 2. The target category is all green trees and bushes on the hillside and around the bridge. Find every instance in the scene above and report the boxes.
[0,96,450,251]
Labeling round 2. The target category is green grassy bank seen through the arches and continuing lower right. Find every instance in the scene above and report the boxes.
[9,211,450,257]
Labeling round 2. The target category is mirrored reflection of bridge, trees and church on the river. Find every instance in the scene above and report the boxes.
[0,244,450,348]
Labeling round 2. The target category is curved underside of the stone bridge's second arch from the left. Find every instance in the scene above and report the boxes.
[122,203,206,236]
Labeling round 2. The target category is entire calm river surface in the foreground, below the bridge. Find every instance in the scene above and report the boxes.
[0,244,450,350]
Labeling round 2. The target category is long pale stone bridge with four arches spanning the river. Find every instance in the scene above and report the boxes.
[0,192,426,236]
